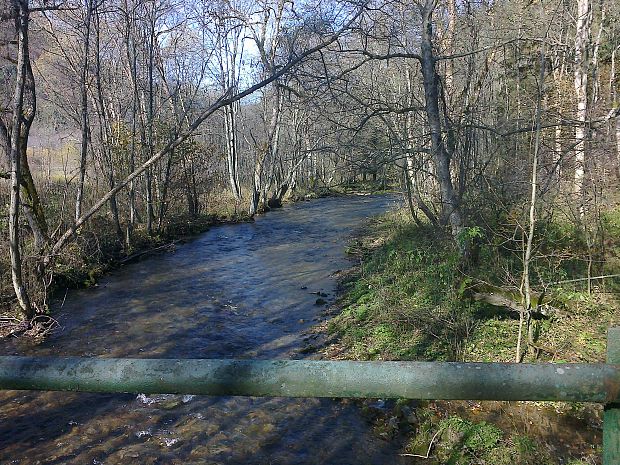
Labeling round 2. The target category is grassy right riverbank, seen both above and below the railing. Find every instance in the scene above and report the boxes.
[323,211,620,465]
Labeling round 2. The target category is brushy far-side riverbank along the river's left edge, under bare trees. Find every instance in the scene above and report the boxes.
[0,182,394,338]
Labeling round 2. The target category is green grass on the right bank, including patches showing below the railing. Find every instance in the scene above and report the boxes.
[328,211,620,465]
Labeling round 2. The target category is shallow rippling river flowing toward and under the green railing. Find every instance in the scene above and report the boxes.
[0,197,404,465]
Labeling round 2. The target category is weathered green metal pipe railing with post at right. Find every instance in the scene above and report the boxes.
[0,327,620,465]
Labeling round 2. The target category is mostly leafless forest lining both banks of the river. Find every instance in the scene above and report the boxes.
[0,0,620,464]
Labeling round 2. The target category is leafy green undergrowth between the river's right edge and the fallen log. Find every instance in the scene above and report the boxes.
[330,214,476,360]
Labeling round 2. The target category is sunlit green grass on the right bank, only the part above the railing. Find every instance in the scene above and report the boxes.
[329,211,620,362]
